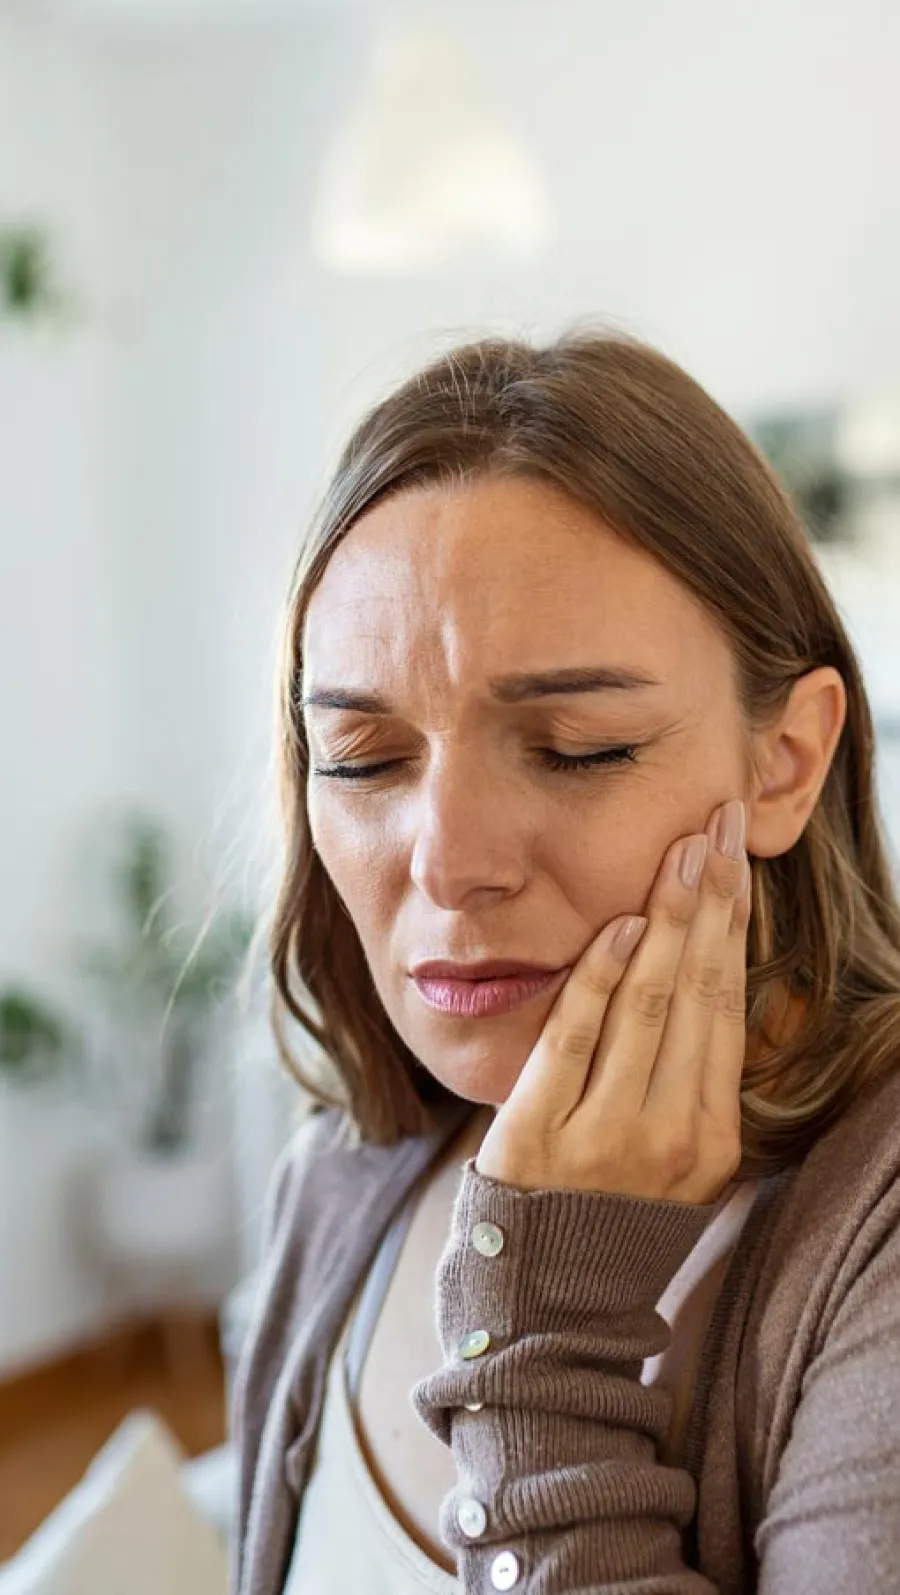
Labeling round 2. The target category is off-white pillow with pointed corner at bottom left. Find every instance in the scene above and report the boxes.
[0,1408,228,1595]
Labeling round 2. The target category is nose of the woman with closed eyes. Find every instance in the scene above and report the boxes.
[410,750,527,909]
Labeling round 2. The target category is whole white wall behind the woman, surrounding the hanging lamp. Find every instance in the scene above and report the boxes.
[0,0,900,1364]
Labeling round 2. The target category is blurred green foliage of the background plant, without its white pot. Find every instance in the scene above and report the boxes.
[80,817,252,1153]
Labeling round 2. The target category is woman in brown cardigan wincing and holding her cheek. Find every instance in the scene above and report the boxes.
[226,333,900,1595]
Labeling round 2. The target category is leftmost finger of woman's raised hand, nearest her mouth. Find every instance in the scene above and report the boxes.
[515,914,646,1123]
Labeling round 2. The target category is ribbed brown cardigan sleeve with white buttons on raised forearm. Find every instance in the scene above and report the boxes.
[412,1158,716,1595]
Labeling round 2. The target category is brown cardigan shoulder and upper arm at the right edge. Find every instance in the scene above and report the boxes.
[750,1073,900,1563]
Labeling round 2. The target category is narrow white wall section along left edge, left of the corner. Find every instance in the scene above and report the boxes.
[0,16,128,1369]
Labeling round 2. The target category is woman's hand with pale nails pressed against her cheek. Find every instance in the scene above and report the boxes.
[476,799,752,1203]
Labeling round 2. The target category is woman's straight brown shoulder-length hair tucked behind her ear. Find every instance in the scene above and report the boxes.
[263,329,900,1172]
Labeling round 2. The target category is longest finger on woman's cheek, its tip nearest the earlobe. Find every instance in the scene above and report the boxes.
[645,803,744,1131]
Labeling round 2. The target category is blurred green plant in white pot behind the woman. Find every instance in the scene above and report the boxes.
[80,815,252,1265]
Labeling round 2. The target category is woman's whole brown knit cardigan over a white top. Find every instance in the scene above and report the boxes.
[230,1072,900,1595]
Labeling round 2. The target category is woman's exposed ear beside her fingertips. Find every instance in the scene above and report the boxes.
[747,665,847,858]
